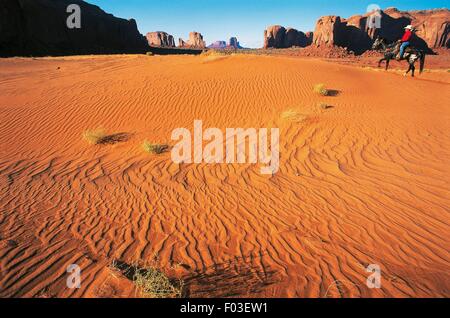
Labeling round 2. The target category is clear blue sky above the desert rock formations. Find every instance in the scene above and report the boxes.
[86,0,448,47]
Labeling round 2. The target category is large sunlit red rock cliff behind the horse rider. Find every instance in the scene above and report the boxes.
[313,8,450,54]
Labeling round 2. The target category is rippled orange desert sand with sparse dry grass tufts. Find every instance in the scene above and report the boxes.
[0,55,450,297]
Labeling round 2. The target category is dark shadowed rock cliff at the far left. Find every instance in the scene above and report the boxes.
[0,0,148,56]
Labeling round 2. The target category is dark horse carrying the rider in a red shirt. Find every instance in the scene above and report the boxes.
[372,36,426,77]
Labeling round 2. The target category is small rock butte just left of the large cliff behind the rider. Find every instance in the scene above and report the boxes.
[264,25,308,48]
